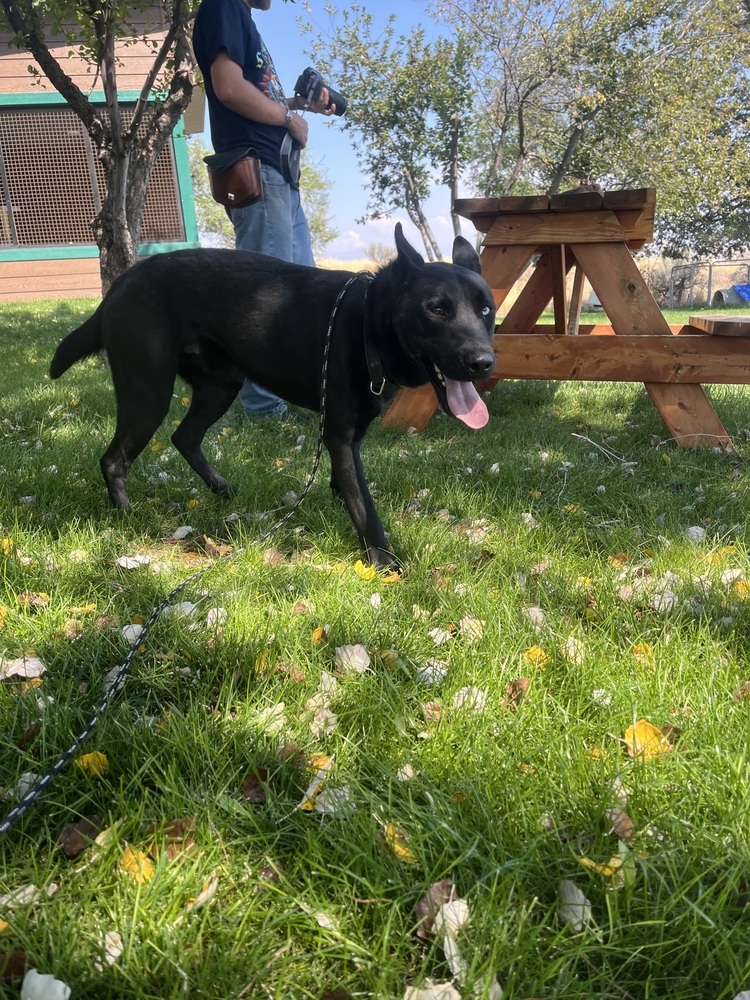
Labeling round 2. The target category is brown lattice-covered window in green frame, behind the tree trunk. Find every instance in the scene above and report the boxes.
[0,106,185,248]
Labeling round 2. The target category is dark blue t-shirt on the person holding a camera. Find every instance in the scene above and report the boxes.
[193,0,287,169]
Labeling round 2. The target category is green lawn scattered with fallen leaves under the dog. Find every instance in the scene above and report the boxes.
[0,302,750,1000]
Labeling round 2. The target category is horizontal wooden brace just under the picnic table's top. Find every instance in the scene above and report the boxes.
[484,211,649,246]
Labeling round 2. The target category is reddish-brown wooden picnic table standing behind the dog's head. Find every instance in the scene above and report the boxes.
[383,188,750,449]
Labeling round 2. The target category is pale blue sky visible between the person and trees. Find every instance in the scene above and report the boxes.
[198,0,458,260]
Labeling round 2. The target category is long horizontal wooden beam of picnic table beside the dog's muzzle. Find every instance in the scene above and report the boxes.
[492,327,750,386]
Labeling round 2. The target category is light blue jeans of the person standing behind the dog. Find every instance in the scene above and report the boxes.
[228,163,315,417]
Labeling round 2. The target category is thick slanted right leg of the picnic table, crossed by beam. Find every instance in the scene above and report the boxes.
[570,243,732,448]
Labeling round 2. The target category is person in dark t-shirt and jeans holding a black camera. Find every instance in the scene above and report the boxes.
[193,0,336,417]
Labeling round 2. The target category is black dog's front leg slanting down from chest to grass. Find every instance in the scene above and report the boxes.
[326,438,399,569]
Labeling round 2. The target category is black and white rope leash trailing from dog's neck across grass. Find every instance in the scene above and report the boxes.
[0,271,373,837]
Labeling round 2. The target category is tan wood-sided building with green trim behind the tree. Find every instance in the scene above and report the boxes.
[0,11,203,303]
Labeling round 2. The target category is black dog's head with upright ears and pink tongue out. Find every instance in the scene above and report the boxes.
[391,223,496,429]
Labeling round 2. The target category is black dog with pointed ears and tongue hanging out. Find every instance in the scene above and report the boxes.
[50,225,495,567]
